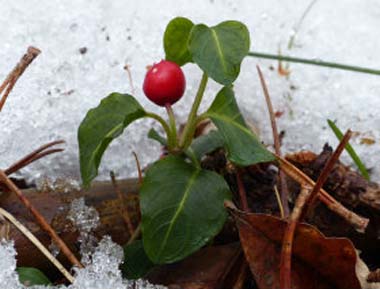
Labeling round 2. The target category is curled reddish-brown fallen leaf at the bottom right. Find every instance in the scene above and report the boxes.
[234,210,361,289]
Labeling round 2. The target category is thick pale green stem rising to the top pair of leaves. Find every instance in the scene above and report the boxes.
[180,73,208,149]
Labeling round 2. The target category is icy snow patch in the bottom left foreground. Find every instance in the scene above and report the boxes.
[0,198,166,289]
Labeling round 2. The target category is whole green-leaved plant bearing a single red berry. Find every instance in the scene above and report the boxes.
[78,17,274,276]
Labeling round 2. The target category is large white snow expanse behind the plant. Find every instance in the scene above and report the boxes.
[0,0,380,180]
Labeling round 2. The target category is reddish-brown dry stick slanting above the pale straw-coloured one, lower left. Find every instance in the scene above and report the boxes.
[0,170,83,268]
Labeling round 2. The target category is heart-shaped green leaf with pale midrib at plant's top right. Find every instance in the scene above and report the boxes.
[189,21,250,85]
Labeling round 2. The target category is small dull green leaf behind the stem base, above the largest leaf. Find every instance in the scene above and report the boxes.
[188,131,224,160]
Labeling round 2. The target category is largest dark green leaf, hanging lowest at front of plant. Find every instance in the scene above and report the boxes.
[140,156,231,264]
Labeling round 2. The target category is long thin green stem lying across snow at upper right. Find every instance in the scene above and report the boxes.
[248,52,380,75]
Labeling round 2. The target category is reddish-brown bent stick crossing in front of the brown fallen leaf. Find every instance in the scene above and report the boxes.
[280,130,352,289]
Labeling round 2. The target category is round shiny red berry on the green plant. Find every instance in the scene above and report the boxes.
[143,60,186,106]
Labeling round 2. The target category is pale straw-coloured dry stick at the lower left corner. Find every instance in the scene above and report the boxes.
[0,208,74,283]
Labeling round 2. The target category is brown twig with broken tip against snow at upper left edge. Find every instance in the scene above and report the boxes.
[0,46,41,111]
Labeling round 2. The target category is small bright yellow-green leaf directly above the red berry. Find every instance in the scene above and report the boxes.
[164,17,194,66]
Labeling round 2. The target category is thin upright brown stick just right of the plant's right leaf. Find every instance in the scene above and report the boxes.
[256,65,289,218]
